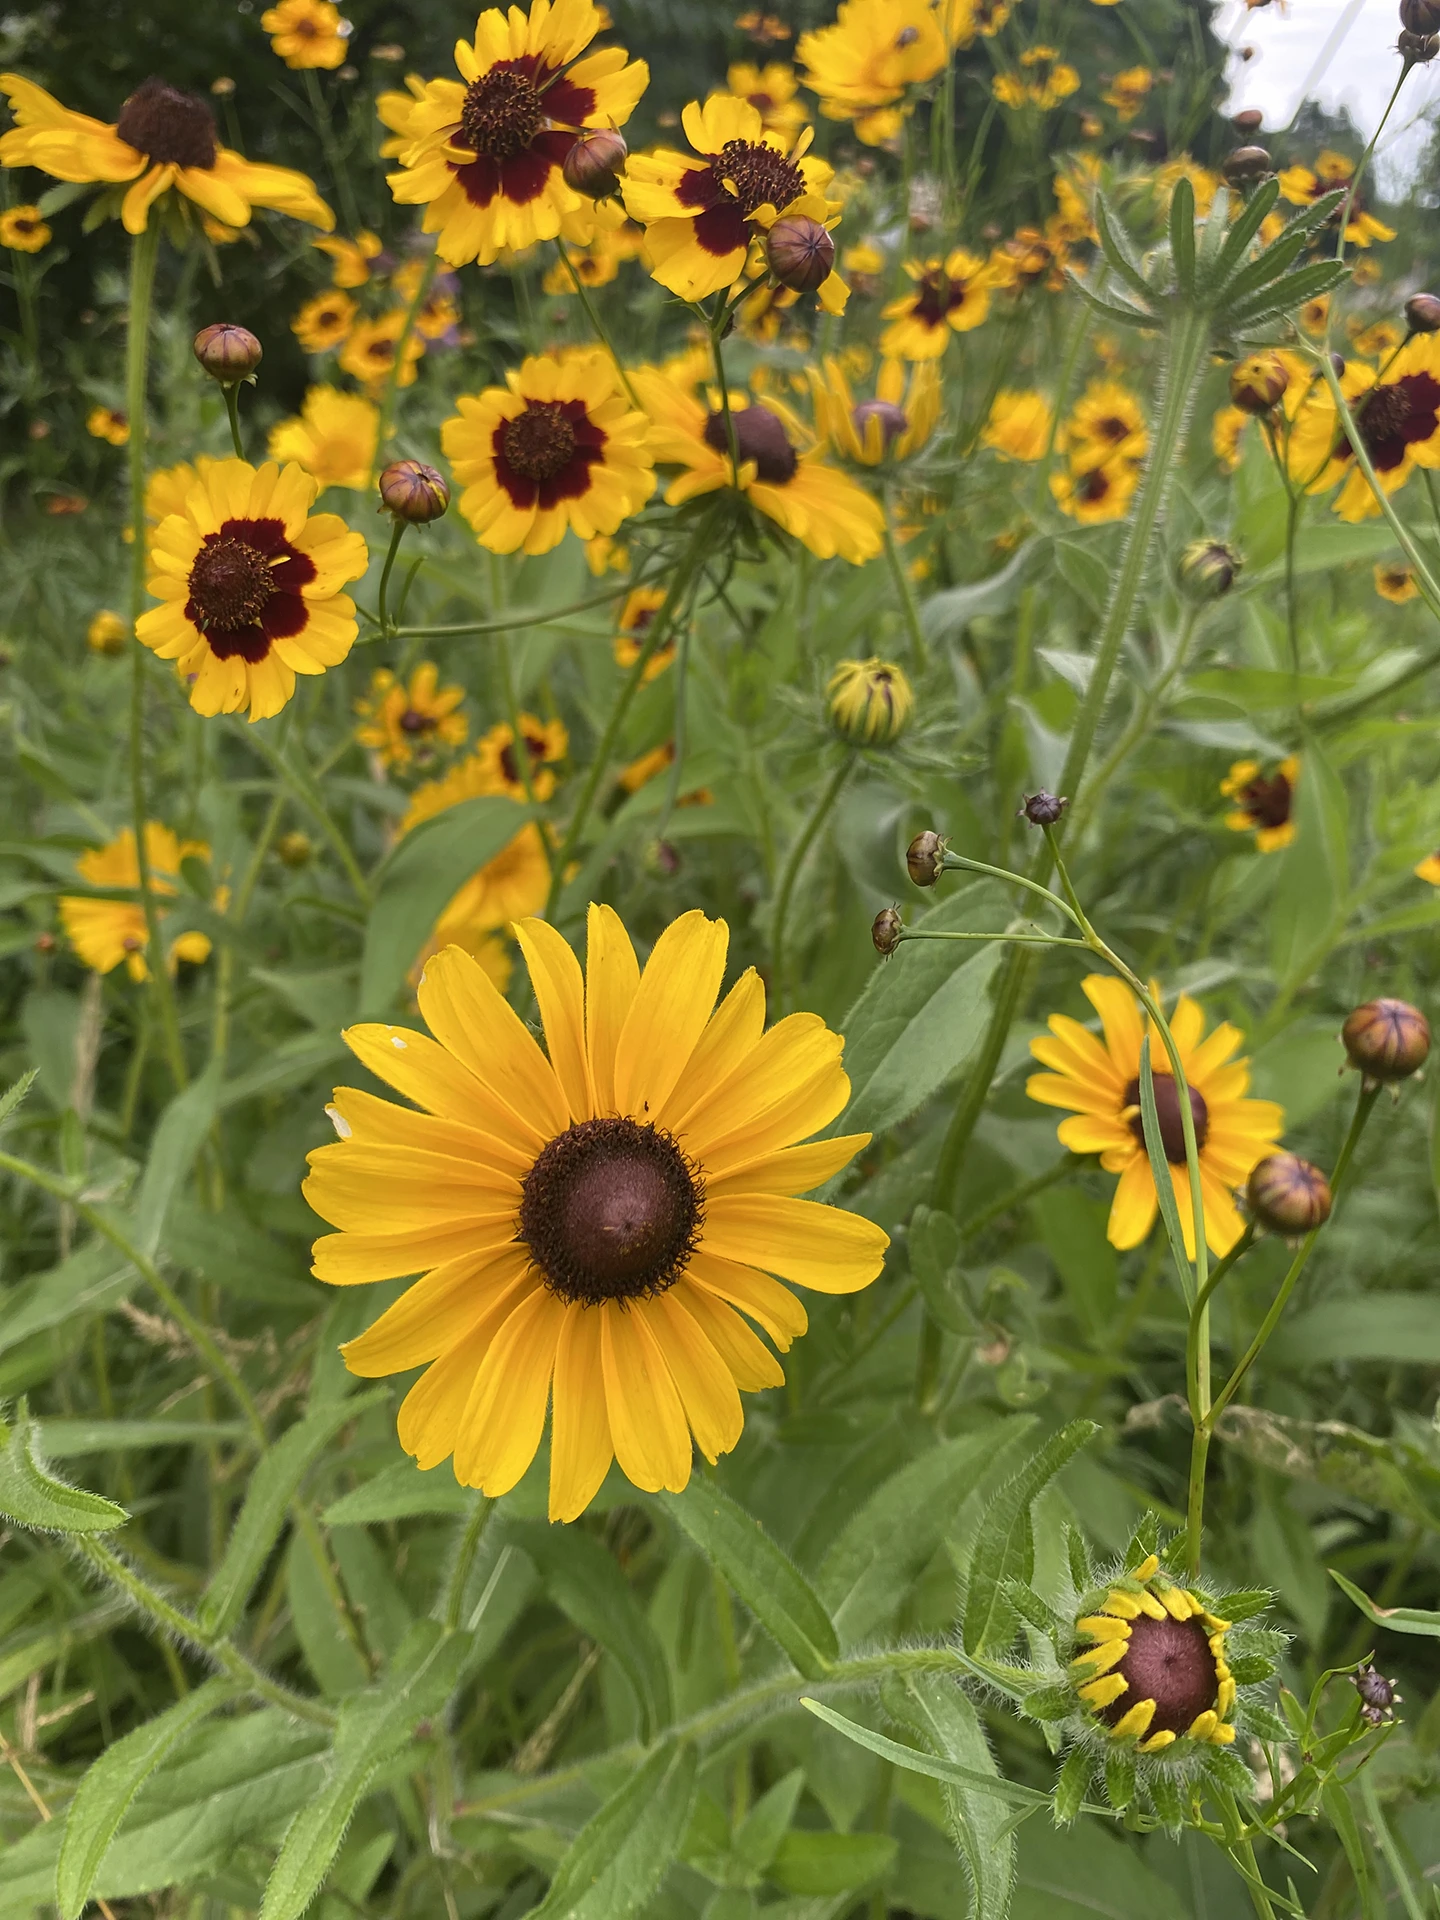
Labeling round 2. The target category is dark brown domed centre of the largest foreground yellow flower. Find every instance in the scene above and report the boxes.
[520,1116,705,1306]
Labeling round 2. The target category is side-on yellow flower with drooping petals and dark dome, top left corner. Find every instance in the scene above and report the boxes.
[0,73,334,234]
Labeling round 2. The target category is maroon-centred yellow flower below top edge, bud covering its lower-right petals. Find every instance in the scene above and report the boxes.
[622,94,847,313]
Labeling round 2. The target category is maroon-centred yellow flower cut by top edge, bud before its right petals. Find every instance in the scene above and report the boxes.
[376,0,649,267]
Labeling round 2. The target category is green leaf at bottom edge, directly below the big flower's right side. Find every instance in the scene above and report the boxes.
[530,1740,695,1920]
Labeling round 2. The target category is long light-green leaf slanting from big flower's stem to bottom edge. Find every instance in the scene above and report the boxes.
[259,1620,468,1920]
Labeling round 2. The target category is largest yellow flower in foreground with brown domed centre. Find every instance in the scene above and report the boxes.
[305,906,887,1521]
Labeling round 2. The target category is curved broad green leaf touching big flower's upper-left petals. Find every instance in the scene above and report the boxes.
[359,795,530,1020]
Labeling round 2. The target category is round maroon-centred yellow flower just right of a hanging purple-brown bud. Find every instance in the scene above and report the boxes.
[440,351,655,553]
